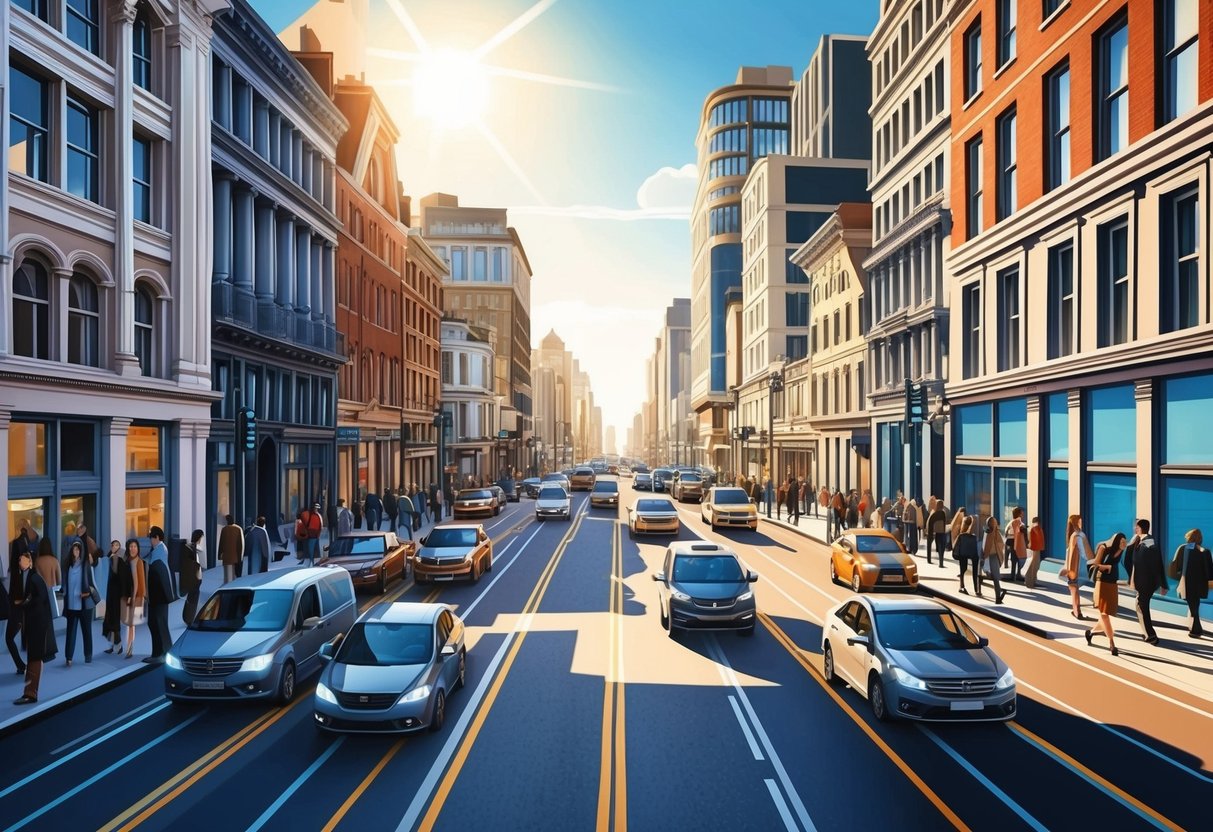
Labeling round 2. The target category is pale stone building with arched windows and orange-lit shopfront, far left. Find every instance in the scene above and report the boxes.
[0,1,227,568]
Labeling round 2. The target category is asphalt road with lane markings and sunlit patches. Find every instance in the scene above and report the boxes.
[0,480,1213,832]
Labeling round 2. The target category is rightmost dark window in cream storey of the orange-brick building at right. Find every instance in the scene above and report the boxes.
[1158,187,1201,332]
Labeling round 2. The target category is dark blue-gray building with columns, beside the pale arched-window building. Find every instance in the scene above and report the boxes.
[204,0,348,548]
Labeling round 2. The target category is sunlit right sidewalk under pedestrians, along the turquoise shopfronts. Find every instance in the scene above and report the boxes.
[758,512,1213,697]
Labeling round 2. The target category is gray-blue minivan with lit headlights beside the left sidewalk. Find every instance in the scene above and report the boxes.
[164,568,358,702]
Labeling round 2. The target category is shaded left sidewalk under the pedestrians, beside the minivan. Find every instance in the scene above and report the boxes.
[0,511,446,735]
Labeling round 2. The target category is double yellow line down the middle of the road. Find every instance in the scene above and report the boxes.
[597,523,627,832]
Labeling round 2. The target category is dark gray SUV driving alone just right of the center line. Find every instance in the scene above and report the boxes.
[653,542,758,638]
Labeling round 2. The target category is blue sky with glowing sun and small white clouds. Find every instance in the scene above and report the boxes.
[251,0,879,450]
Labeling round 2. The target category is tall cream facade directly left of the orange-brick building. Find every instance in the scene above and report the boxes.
[864,0,955,509]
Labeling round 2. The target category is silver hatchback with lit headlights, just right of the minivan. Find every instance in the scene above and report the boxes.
[313,603,467,734]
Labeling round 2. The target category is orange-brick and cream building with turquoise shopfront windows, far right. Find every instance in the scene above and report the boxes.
[947,0,1213,567]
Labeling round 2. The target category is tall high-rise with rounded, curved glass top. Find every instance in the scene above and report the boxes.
[690,67,792,475]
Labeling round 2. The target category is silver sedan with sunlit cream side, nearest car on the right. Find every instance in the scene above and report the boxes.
[821,595,1015,722]
